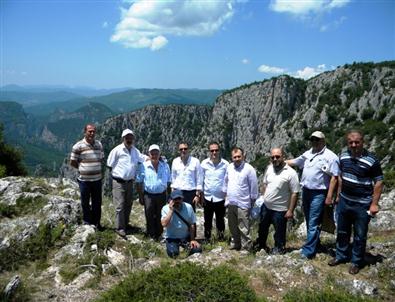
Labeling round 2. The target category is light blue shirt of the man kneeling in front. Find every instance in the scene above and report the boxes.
[162,202,196,239]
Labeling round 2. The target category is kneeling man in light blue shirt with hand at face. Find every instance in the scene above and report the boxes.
[161,190,202,258]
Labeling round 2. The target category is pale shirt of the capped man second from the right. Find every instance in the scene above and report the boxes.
[292,147,339,190]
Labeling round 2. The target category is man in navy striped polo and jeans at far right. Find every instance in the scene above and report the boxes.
[328,130,384,275]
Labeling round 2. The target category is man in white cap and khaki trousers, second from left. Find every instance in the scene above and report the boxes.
[107,129,145,237]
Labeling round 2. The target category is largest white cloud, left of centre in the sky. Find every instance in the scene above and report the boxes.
[111,0,235,50]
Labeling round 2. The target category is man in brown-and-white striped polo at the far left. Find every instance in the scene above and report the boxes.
[70,124,104,230]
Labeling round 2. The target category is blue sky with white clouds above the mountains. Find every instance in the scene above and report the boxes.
[0,0,395,89]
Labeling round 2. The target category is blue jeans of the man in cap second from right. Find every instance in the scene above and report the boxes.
[302,188,328,258]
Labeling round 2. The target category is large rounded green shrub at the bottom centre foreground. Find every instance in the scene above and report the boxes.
[98,262,258,302]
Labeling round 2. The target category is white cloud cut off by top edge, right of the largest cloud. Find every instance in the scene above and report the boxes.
[269,0,351,15]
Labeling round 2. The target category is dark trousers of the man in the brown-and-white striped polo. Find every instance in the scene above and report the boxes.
[78,180,102,226]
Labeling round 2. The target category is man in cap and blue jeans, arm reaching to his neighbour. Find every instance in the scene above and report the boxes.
[286,131,339,259]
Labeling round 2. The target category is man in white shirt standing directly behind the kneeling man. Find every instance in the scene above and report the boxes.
[171,143,202,211]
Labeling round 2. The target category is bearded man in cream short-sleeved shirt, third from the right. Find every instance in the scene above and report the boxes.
[256,148,300,254]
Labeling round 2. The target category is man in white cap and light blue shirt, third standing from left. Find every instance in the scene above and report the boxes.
[136,144,171,240]
